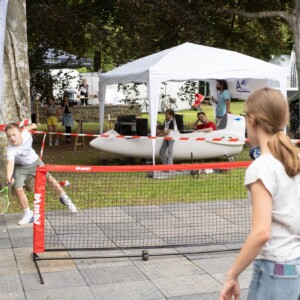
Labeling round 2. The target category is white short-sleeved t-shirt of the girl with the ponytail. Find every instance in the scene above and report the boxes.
[245,153,300,262]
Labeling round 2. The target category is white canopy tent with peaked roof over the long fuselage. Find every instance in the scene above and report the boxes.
[99,43,287,159]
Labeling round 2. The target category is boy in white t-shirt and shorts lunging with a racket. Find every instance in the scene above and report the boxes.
[5,123,77,225]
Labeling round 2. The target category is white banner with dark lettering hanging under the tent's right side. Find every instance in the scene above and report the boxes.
[228,78,268,100]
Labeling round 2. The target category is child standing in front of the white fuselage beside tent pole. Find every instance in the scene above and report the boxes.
[159,109,175,165]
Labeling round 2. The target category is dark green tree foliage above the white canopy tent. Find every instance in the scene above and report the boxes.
[27,0,293,75]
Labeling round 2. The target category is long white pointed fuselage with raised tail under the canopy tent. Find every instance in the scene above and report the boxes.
[90,114,245,160]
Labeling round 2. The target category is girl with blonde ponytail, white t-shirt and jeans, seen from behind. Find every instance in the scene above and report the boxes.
[220,88,300,300]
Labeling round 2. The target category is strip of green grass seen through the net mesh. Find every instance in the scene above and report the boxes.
[42,169,247,210]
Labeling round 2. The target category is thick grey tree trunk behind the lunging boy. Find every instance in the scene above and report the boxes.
[0,0,30,186]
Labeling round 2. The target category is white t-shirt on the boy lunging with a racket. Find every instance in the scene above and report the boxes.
[6,130,39,166]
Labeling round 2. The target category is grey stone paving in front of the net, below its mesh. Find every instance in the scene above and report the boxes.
[0,214,251,300]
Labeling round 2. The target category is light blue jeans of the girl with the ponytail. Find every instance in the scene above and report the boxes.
[247,258,300,300]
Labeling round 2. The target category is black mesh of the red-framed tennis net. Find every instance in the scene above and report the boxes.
[39,164,250,251]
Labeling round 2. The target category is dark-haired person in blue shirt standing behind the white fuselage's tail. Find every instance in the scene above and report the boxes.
[216,80,231,127]
